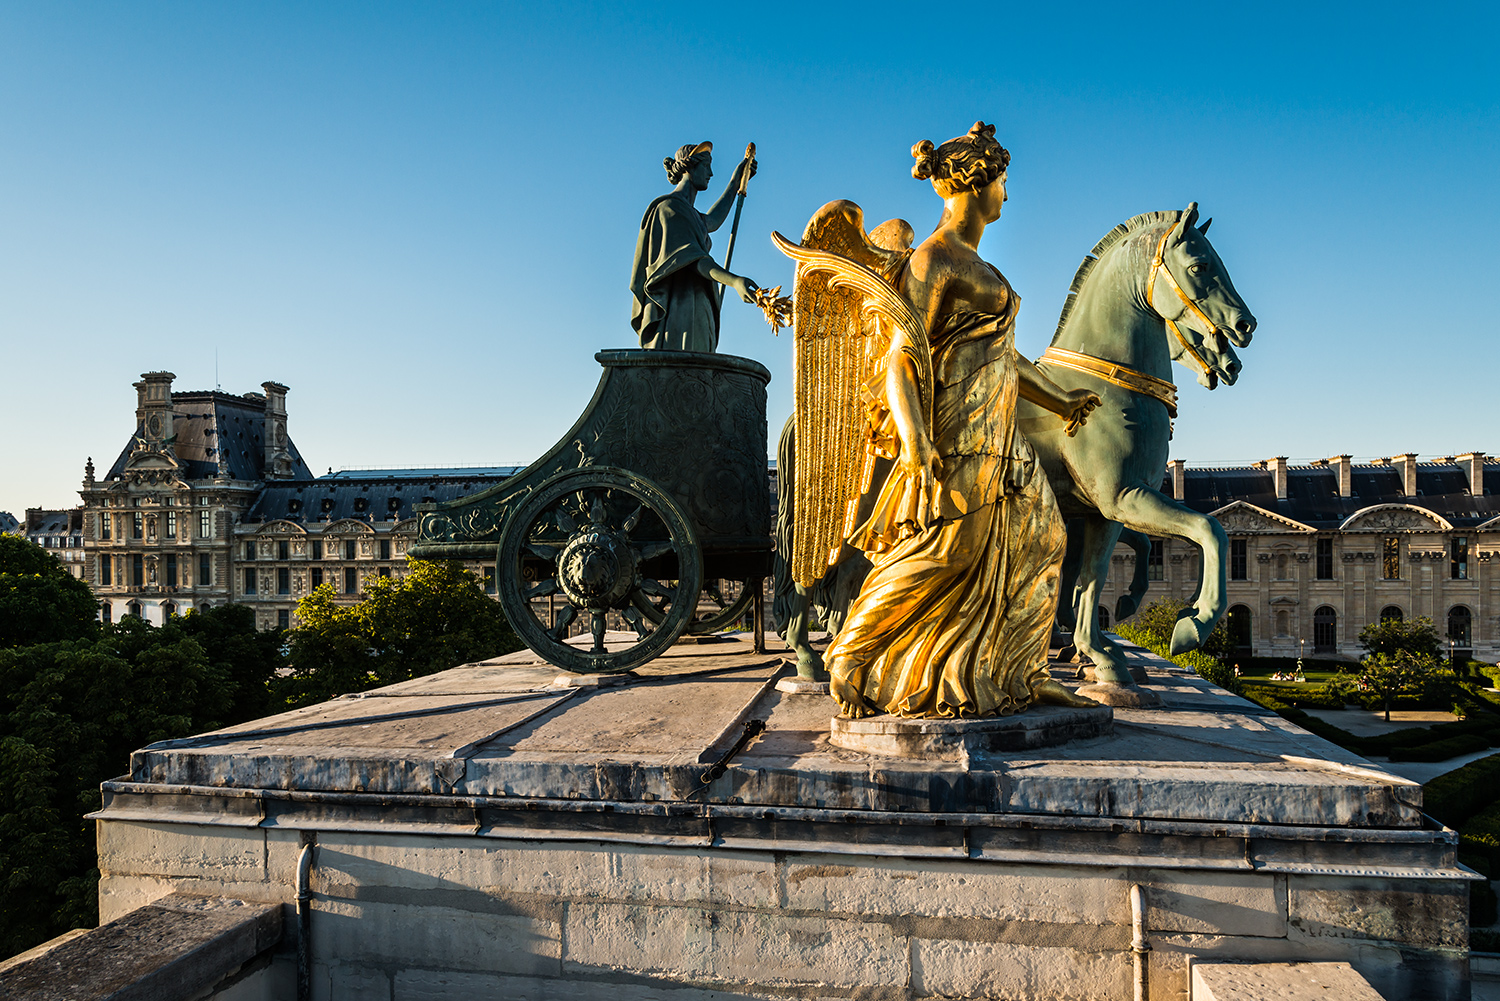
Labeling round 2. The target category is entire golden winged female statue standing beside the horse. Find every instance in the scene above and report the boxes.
[773,123,1098,717]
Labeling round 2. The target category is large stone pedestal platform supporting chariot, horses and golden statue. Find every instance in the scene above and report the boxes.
[95,638,1478,1001]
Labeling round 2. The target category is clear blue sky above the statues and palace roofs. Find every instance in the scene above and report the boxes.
[0,2,1500,525]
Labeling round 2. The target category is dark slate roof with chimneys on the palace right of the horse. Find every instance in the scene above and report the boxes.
[1161,462,1500,530]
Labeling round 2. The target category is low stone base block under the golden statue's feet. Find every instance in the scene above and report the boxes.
[828,705,1115,761]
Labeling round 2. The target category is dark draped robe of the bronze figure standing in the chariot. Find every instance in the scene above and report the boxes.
[630,191,719,351]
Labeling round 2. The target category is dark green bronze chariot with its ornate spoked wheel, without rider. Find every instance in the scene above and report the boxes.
[411,350,773,672]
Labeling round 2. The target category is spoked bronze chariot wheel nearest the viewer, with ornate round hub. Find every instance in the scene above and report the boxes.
[497,467,704,674]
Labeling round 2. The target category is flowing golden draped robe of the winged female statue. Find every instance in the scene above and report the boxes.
[827,285,1067,717]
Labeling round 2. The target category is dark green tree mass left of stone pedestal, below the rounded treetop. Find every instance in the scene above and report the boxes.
[0,606,282,954]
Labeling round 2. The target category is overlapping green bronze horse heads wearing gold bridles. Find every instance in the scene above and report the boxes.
[1146,201,1256,389]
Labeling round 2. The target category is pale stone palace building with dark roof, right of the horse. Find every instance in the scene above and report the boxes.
[1100,452,1500,662]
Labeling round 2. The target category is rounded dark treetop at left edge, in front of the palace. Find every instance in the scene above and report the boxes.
[0,534,99,647]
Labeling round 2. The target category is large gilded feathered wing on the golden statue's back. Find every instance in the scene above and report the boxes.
[771,201,932,587]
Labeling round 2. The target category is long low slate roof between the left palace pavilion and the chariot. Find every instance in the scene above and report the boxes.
[242,465,524,524]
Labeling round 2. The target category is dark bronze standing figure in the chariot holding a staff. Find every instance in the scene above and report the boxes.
[630,143,759,351]
